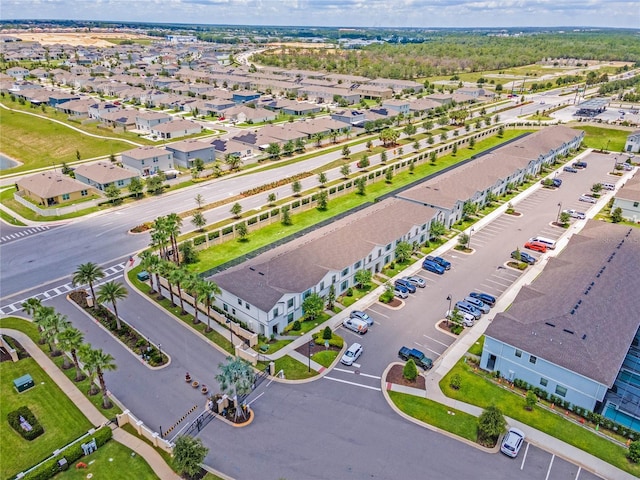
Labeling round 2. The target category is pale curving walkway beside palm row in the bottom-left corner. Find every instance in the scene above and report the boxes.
[0,328,180,480]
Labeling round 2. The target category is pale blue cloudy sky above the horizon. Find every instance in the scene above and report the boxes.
[0,0,640,28]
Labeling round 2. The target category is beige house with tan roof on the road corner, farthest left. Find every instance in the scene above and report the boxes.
[16,172,97,207]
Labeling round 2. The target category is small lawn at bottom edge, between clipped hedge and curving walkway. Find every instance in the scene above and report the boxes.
[55,440,158,480]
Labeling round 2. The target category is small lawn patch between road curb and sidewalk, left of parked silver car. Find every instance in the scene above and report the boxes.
[388,392,478,442]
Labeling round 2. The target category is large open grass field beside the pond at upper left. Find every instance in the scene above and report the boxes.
[0,109,134,173]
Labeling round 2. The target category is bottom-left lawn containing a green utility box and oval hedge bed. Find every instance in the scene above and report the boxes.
[0,358,93,478]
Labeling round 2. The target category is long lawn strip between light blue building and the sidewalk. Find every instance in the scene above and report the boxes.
[440,360,640,477]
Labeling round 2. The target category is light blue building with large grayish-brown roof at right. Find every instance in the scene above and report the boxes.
[480,220,640,431]
